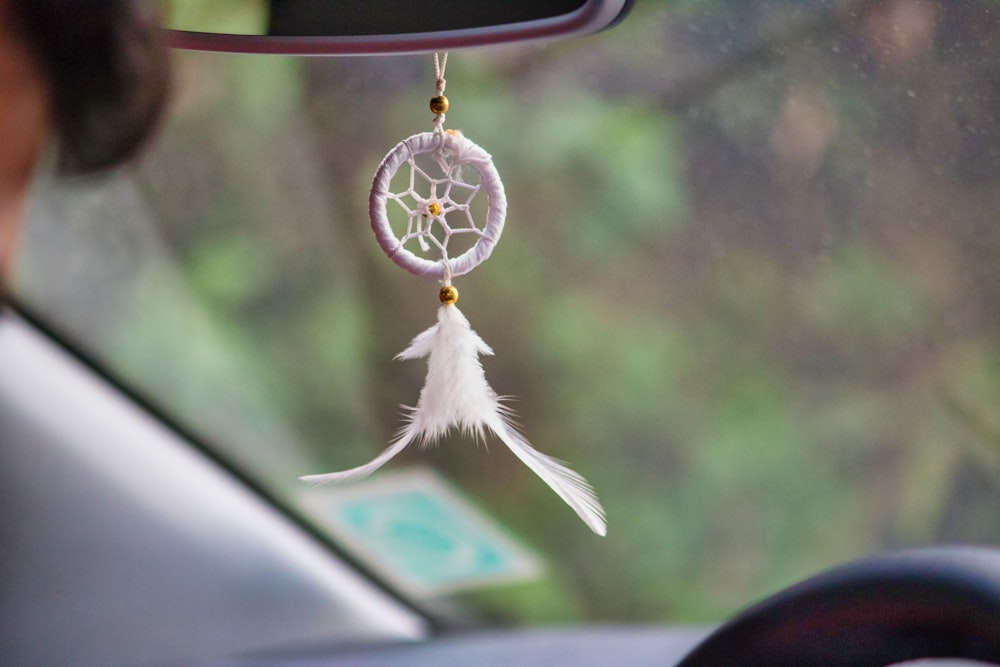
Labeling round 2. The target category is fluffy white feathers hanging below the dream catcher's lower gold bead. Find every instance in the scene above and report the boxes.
[301,305,607,535]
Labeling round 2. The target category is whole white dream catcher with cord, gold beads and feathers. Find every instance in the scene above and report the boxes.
[301,54,607,535]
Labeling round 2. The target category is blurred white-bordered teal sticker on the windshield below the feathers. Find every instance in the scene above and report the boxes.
[307,468,541,595]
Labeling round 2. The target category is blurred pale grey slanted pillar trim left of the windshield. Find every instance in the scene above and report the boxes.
[0,312,428,665]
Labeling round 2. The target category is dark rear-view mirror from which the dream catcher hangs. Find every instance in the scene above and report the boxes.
[162,0,633,55]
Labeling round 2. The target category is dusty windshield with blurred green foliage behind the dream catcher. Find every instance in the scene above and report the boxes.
[15,0,1000,625]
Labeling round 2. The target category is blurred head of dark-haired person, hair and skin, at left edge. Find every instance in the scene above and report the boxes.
[0,0,168,286]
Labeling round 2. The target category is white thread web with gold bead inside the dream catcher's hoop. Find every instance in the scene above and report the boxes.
[387,156,484,259]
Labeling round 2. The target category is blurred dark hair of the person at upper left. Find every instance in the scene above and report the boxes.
[0,0,169,174]
